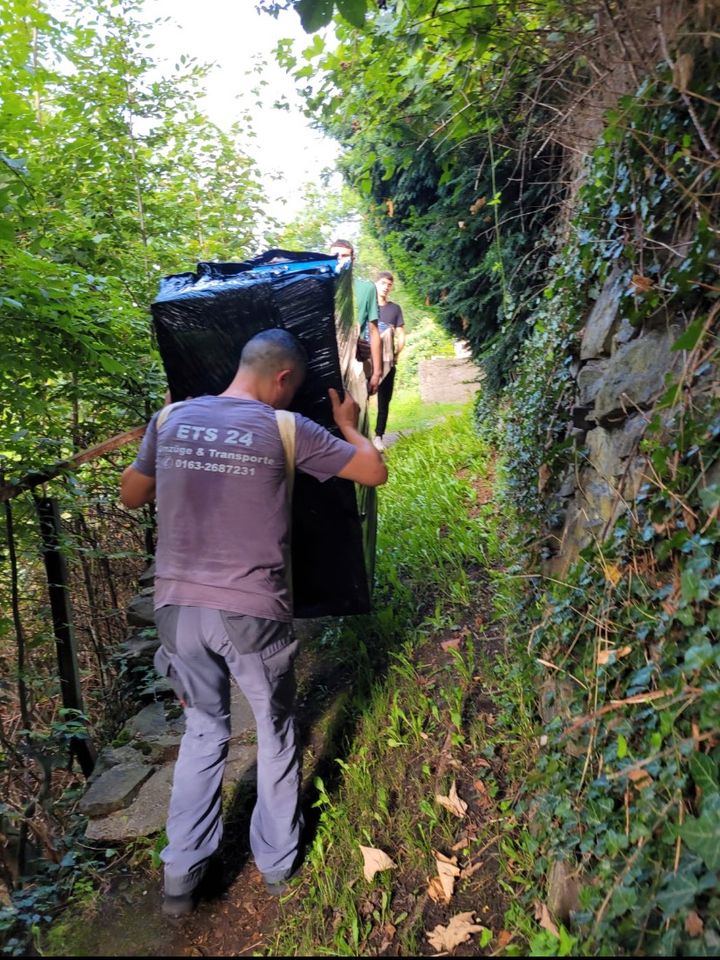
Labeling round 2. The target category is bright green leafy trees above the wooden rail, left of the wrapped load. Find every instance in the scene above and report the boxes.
[0,0,262,473]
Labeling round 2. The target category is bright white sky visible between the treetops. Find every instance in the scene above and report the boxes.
[145,0,337,221]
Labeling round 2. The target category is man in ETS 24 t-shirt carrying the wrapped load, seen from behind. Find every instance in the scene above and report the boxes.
[121,329,387,917]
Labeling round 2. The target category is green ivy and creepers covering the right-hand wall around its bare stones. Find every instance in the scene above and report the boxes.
[480,43,720,955]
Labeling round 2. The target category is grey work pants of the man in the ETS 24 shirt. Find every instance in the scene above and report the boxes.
[155,606,302,896]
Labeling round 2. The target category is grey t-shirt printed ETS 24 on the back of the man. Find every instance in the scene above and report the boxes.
[133,396,355,622]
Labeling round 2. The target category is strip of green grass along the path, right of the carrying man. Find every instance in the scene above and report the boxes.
[266,409,512,956]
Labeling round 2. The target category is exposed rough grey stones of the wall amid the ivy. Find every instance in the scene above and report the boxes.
[538,271,712,577]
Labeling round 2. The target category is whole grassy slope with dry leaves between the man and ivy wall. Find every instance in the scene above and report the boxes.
[267,408,530,956]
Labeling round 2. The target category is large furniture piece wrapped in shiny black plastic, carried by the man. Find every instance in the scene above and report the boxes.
[151,250,374,617]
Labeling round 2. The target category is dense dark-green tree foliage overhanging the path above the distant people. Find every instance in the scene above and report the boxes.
[278,2,568,387]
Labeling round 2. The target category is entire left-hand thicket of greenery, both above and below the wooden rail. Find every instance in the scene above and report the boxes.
[0,0,272,953]
